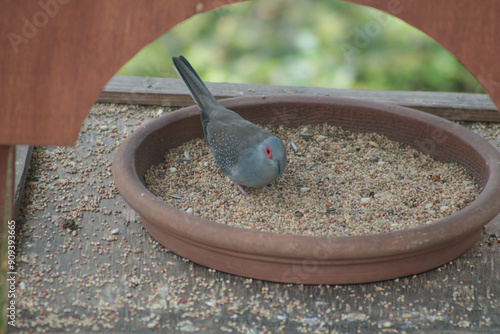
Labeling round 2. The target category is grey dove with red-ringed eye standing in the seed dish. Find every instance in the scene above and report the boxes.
[172,56,287,196]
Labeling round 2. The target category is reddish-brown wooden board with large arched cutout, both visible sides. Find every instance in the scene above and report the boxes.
[0,0,500,145]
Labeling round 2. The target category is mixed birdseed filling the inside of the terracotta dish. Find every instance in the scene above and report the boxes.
[146,124,480,236]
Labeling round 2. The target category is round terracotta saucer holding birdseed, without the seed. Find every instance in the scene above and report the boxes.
[113,95,500,284]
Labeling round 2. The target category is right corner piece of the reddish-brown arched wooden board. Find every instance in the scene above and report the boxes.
[349,0,500,106]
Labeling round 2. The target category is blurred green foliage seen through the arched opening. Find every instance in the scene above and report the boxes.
[117,0,484,93]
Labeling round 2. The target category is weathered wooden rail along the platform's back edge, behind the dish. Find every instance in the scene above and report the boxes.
[97,76,500,122]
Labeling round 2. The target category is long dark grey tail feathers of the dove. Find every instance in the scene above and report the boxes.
[172,56,218,112]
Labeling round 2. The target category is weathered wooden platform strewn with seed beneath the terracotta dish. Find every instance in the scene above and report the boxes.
[8,78,500,333]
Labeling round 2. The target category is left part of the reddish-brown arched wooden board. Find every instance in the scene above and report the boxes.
[0,0,242,145]
